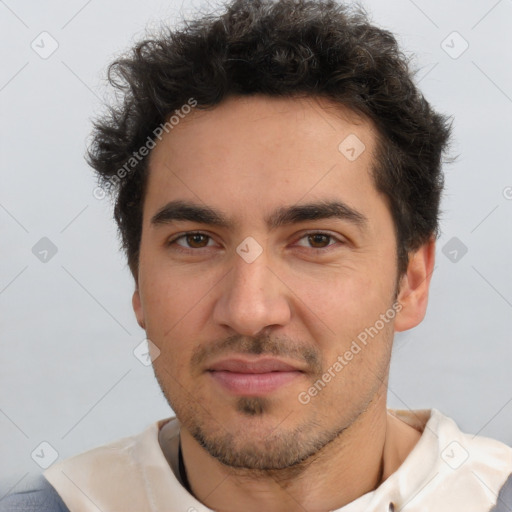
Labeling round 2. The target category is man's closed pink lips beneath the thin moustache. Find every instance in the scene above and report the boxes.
[207,358,304,396]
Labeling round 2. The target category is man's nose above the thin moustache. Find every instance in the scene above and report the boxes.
[213,247,291,336]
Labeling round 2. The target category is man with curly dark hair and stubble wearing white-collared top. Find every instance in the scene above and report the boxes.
[0,0,512,512]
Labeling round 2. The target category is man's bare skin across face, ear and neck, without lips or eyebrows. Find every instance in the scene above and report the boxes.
[133,96,435,512]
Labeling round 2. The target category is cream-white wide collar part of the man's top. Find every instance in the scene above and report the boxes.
[43,409,512,512]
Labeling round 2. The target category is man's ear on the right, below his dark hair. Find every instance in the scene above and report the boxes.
[395,237,436,332]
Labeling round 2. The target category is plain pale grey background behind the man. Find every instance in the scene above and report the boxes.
[0,0,512,496]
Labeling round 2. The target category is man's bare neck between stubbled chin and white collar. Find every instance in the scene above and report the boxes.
[174,395,421,512]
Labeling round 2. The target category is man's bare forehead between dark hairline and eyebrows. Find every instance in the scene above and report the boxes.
[145,96,382,226]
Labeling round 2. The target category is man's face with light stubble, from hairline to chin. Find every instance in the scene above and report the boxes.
[134,96,406,469]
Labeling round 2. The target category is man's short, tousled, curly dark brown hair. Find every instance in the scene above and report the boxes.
[87,0,451,279]
